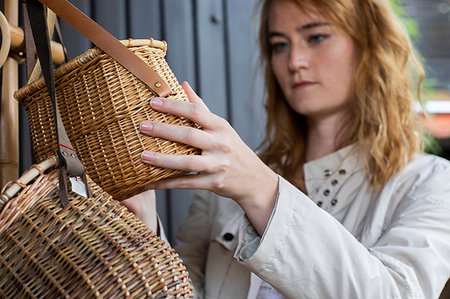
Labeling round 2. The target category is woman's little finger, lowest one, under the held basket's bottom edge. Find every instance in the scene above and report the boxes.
[145,174,213,190]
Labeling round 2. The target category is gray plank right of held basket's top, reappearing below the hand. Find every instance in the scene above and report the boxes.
[158,0,196,241]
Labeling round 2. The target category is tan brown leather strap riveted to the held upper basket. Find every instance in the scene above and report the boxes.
[39,0,171,97]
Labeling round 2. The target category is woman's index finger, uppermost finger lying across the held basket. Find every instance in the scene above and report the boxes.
[150,98,221,128]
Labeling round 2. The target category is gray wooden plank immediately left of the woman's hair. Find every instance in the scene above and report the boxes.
[226,0,265,149]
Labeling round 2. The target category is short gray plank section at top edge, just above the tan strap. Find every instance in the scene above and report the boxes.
[93,0,128,39]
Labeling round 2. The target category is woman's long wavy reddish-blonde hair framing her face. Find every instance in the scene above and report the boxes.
[259,0,424,190]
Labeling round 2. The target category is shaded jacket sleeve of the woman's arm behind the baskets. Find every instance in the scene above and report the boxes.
[174,191,211,298]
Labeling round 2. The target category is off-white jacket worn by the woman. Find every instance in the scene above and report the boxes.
[176,147,450,299]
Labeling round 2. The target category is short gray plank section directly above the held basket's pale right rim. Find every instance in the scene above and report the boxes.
[126,0,161,39]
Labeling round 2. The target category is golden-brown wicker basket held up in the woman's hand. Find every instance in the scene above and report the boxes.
[15,39,199,200]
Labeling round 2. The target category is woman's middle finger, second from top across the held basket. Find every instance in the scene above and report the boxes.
[140,120,210,149]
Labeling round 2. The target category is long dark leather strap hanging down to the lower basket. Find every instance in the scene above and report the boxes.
[26,0,92,206]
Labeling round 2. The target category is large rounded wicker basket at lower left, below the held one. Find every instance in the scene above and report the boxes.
[0,158,193,298]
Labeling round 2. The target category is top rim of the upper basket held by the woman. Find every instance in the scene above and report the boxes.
[14,38,167,102]
